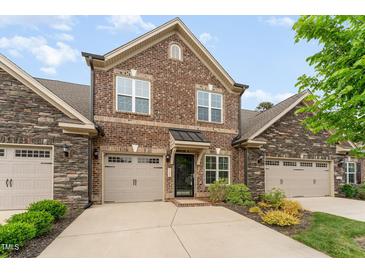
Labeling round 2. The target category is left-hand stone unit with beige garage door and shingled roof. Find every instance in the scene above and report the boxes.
[0,55,96,210]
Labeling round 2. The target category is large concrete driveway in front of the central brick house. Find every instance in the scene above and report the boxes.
[40,202,326,258]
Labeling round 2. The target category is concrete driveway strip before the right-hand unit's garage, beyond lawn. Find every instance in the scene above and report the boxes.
[295,197,365,222]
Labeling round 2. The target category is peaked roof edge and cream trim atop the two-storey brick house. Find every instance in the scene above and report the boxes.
[82,18,248,92]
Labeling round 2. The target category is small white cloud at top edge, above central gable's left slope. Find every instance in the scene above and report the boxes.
[97,15,155,33]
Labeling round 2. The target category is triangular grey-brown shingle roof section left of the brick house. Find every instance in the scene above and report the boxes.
[35,78,90,117]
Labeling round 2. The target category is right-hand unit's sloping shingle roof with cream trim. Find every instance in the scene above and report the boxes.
[234,92,308,144]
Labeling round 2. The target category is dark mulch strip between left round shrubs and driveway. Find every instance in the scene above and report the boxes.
[9,209,83,258]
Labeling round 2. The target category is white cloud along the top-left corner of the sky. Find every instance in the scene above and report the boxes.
[0,15,75,31]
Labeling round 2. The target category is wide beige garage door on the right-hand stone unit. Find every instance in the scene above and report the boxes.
[265,159,331,197]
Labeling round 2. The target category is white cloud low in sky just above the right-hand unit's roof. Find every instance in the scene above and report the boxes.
[242,89,295,106]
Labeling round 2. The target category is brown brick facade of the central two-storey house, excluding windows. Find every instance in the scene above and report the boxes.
[93,34,242,202]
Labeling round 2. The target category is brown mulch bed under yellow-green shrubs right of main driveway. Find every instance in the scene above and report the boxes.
[222,204,312,237]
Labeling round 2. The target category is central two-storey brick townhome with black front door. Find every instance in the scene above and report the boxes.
[83,19,247,203]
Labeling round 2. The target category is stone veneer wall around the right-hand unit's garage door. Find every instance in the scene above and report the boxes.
[243,104,344,196]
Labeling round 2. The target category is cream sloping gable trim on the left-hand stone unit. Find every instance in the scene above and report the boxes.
[0,54,94,127]
